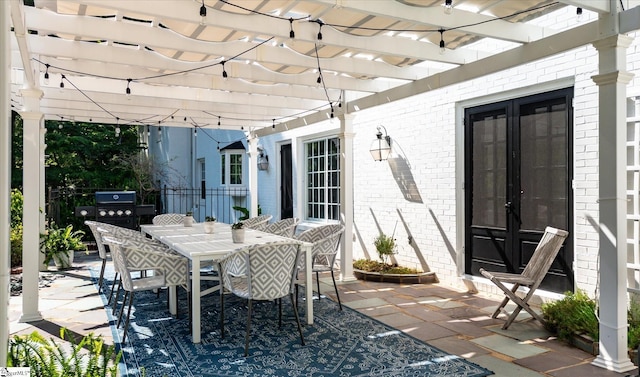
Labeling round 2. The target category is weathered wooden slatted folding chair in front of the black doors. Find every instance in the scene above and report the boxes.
[480,227,569,330]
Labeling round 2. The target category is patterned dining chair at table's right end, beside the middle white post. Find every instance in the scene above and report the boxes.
[294,224,344,310]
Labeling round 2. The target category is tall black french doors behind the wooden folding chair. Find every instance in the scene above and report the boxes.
[465,88,573,292]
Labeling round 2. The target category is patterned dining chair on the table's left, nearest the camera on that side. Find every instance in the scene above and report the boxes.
[103,234,190,343]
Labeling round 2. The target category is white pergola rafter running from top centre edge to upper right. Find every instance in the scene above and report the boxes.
[309,0,556,43]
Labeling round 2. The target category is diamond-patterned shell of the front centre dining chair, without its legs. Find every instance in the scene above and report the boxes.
[221,241,300,300]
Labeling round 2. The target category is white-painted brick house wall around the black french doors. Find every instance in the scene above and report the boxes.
[260,25,640,296]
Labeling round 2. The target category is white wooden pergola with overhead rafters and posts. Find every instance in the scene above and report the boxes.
[0,0,640,371]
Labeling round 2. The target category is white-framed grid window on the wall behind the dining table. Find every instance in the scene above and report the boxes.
[304,137,340,221]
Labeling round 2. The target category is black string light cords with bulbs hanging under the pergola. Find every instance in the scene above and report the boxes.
[32,0,568,130]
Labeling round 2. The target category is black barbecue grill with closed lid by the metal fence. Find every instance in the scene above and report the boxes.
[75,191,155,229]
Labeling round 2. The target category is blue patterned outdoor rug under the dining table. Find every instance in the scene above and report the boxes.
[92,271,493,377]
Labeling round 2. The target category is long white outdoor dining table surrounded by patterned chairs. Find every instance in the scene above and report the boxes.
[140,222,313,343]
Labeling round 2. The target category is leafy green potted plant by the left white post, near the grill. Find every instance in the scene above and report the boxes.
[40,223,87,269]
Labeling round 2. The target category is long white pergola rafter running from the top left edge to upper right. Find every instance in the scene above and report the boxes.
[69,0,484,64]
